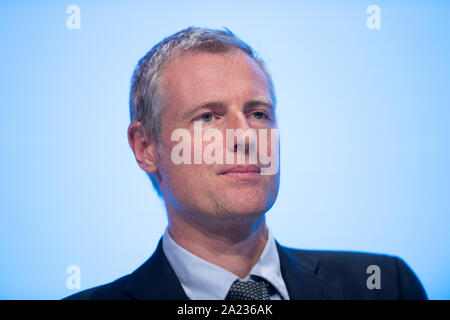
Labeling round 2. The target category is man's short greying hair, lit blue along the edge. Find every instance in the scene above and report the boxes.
[130,27,276,196]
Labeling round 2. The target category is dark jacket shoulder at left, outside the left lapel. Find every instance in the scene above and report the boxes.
[63,275,133,300]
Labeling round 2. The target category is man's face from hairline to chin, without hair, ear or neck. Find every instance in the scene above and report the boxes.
[158,50,279,224]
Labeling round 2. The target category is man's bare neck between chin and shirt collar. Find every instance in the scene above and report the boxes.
[168,212,268,278]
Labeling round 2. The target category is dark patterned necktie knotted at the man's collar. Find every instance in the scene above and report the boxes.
[225,279,270,300]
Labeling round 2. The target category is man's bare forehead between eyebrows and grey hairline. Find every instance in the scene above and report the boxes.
[159,50,270,113]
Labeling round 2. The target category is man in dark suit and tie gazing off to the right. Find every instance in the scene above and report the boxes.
[65,28,426,300]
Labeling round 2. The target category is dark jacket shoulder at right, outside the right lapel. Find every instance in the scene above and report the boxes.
[280,246,427,299]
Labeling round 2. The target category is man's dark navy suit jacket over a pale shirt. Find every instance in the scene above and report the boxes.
[65,239,427,300]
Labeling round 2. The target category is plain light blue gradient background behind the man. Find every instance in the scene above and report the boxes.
[0,0,450,299]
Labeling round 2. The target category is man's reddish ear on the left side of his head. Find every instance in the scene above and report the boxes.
[128,121,158,173]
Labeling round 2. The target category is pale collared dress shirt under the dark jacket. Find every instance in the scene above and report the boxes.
[162,228,289,300]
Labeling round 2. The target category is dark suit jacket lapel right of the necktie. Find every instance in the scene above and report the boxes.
[276,242,343,300]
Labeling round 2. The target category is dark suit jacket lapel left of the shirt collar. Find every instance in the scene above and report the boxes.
[125,238,189,300]
